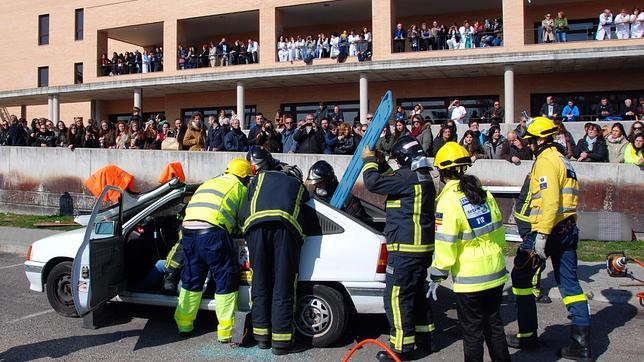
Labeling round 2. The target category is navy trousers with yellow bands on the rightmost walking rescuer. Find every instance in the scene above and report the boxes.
[512,217,590,338]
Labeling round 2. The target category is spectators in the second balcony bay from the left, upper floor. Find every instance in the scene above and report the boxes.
[177,38,259,69]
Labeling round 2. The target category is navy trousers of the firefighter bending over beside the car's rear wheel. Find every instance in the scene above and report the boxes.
[246,222,302,348]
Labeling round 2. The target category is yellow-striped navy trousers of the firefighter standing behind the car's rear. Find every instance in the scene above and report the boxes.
[384,252,436,353]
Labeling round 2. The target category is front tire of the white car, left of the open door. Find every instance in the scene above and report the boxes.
[46,261,78,317]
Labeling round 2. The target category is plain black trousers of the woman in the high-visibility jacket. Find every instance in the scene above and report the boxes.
[454,285,510,362]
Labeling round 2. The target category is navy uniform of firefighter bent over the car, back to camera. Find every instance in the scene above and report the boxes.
[240,171,309,348]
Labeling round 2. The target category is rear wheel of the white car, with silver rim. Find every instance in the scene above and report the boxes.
[294,284,348,348]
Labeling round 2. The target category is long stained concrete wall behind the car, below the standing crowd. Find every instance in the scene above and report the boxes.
[0,147,644,231]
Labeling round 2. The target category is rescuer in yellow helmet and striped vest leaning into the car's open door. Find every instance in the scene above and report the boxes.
[174,158,251,343]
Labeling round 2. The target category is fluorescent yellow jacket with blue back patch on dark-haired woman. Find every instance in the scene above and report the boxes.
[432,180,508,293]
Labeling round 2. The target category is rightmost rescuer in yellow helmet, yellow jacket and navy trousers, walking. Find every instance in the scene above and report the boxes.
[508,117,592,361]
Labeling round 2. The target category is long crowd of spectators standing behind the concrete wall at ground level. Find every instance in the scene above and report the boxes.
[0,97,644,165]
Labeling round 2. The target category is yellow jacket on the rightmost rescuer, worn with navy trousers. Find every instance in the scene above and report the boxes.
[530,145,579,235]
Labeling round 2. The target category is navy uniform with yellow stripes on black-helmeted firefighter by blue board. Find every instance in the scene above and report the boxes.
[362,157,436,353]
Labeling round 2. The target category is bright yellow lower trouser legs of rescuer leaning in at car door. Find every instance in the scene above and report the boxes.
[174,288,239,342]
